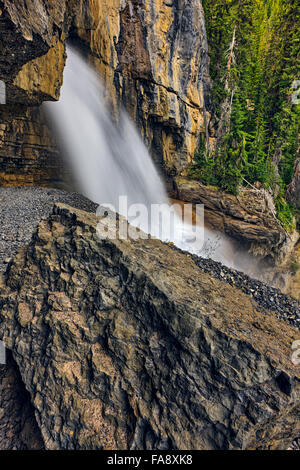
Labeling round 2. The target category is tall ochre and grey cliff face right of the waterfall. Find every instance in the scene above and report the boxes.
[75,0,208,176]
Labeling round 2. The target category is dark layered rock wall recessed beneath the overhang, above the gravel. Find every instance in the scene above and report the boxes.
[0,105,65,186]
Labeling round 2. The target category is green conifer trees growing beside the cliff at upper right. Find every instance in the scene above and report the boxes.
[190,0,300,227]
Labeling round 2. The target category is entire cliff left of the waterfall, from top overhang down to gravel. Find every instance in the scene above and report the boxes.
[0,0,68,185]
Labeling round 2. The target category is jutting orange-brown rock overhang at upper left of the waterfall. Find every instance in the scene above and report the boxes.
[0,0,68,100]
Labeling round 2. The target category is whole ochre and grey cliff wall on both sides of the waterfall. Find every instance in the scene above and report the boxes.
[0,0,208,187]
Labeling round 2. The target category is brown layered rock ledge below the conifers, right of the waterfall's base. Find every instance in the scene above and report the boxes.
[174,178,299,263]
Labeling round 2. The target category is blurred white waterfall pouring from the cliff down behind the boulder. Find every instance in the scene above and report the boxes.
[46,47,260,274]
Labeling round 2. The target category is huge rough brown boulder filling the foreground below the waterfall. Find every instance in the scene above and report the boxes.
[0,205,300,449]
